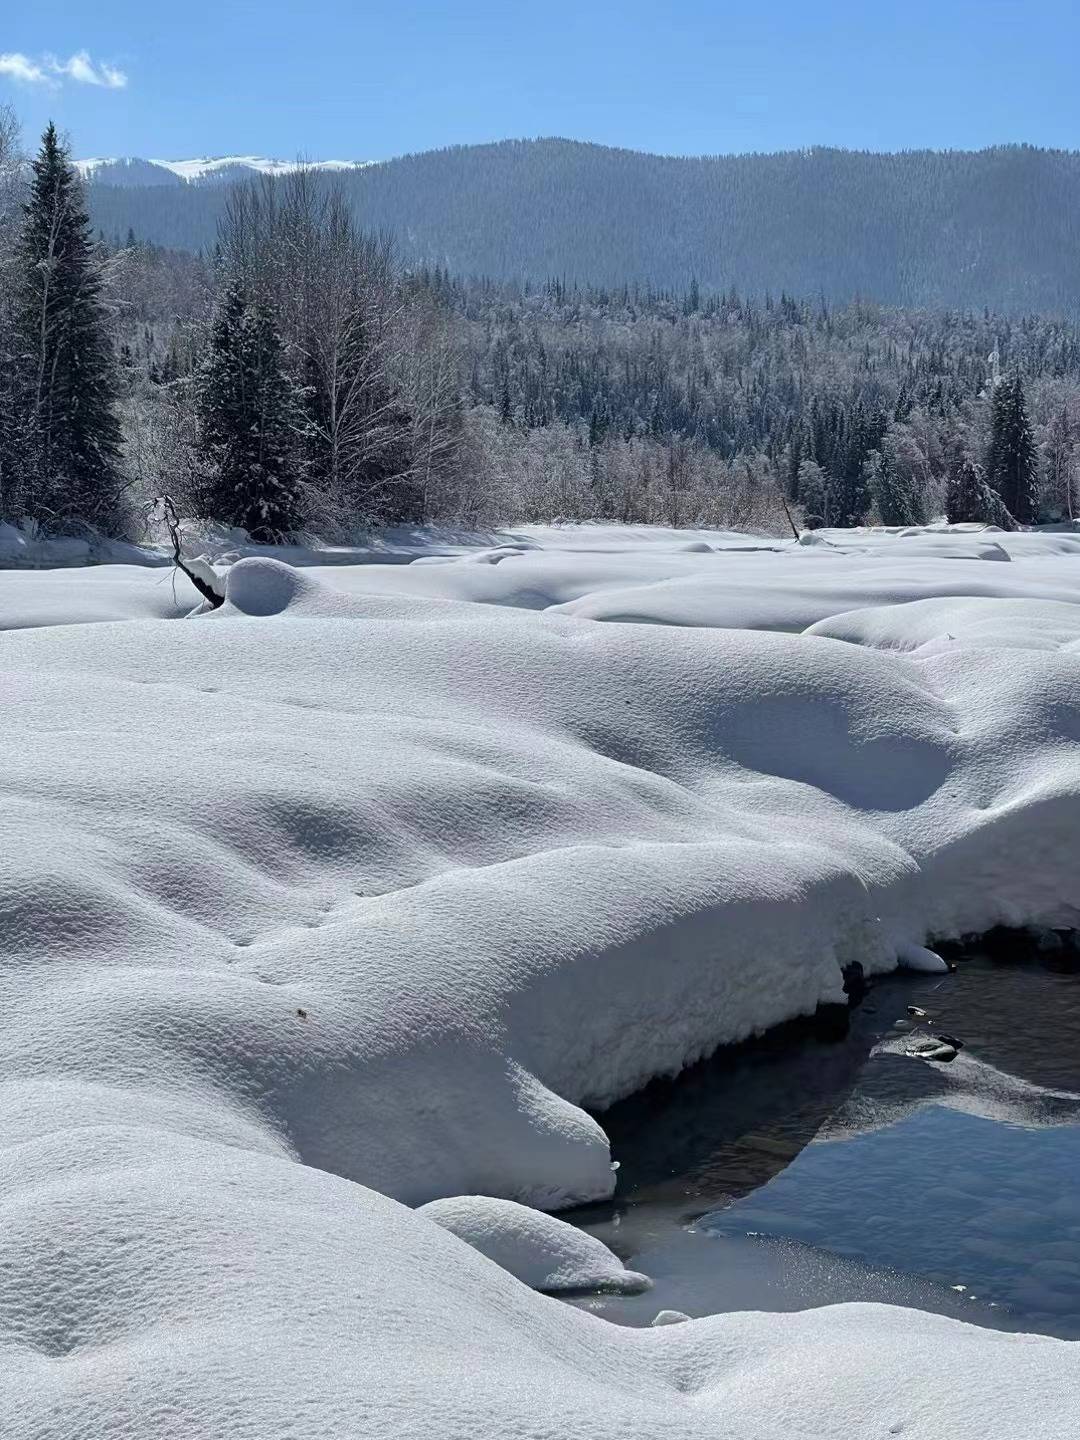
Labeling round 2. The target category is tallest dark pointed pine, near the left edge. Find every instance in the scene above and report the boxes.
[16,124,121,524]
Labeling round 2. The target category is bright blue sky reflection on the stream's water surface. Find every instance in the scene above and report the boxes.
[697,1104,1080,1338]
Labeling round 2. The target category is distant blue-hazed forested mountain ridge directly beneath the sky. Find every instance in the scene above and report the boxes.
[91,140,1080,314]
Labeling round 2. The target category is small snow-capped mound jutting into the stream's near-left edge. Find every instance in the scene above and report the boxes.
[418,1195,651,1295]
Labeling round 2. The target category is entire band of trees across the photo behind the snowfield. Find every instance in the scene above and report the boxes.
[0,115,1080,540]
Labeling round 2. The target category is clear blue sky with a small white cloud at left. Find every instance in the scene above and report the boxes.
[0,0,1080,160]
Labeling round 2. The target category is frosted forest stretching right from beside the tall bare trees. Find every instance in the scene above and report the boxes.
[440,269,1080,526]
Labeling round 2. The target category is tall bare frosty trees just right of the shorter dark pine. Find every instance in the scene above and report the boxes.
[219,178,429,533]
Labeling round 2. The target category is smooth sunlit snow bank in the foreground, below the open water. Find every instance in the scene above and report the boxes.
[0,1140,1080,1440]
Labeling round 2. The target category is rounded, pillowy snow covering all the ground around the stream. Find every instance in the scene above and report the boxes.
[0,527,1080,1440]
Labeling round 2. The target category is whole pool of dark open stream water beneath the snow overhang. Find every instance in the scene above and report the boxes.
[567,956,1080,1339]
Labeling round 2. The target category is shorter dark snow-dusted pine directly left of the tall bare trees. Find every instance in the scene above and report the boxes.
[197,281,304,544]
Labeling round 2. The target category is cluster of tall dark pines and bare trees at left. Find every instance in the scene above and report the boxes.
[0,117,462,543]
